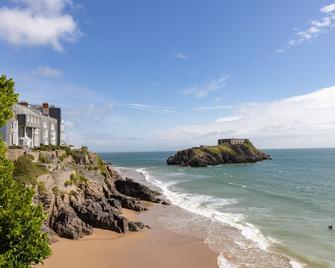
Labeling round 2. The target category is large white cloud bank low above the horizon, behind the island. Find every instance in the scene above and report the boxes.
[160,86,335,148]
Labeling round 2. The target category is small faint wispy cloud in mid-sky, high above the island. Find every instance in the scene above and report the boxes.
[182,73,229,98]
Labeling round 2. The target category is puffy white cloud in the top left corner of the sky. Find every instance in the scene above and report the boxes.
[0,0,79,51]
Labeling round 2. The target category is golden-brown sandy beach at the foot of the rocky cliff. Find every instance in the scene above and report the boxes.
[37,205,218,268]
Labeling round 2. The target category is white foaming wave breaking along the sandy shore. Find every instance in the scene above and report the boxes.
[136,168,302,268]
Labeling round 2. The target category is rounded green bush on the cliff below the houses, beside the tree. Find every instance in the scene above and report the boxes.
[13,155,47,185]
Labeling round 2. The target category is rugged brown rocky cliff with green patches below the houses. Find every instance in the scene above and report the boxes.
[10,147,167,239]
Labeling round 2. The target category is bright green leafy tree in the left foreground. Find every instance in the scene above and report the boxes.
[0,75,50,268]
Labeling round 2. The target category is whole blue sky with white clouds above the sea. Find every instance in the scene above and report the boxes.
[0,0,335,152]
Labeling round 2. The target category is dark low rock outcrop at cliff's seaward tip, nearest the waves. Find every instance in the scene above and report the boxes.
[115,178,171,205]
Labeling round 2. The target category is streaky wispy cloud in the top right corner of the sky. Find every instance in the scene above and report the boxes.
[277,3,335,53]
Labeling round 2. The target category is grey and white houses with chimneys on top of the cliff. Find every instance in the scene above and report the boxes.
[0,102,64,148]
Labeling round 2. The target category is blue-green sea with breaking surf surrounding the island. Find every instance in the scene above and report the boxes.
[101,149,335,267]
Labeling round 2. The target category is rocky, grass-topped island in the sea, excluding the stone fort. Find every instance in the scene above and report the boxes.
[166,141,270,167]
